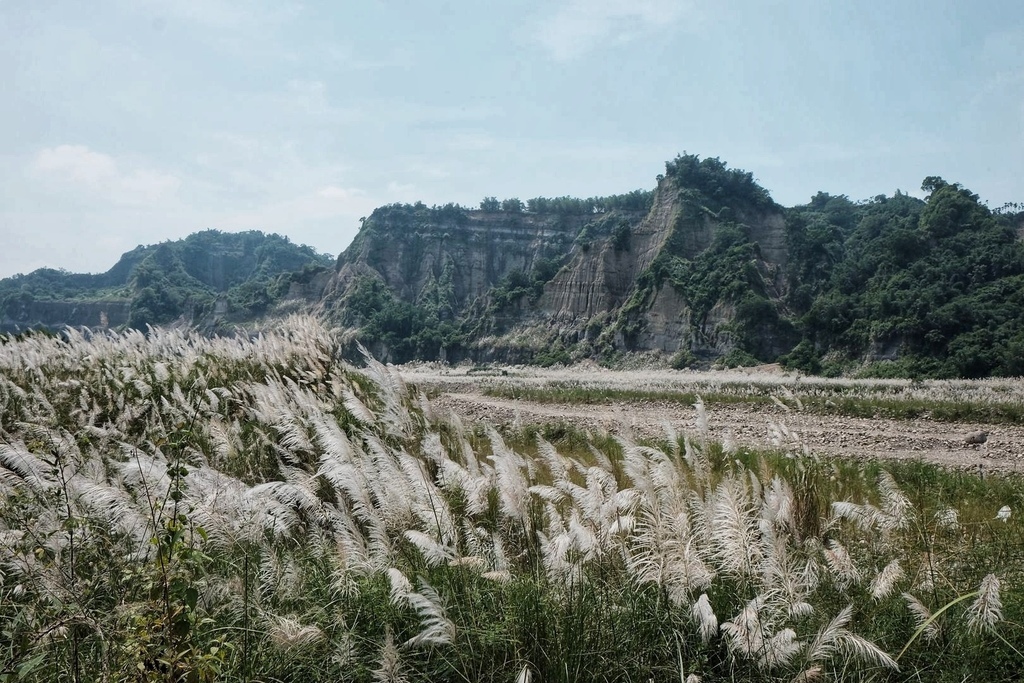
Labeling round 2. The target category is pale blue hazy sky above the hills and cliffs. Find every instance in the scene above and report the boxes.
[0,0,1024,276]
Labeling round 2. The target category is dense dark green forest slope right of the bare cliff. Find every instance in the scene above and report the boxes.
[785,177,1024,377]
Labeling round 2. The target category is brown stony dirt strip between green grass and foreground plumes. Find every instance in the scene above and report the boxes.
[421,384,1024,472]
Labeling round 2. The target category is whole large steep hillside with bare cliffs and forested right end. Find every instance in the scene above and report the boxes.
[318,155,1024,377]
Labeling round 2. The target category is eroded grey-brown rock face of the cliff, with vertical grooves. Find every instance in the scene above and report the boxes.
[318,168,792,360]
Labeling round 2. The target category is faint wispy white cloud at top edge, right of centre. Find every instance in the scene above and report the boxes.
[538,0,689,61]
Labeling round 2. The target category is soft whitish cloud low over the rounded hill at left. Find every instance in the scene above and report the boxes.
[29,144,181,206]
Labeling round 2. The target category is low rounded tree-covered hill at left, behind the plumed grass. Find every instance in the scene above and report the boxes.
[0,230,331,332]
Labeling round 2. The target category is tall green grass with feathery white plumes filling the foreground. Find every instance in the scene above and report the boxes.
[0,318,1024,682]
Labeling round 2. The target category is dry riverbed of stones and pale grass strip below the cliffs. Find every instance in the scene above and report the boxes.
[399,366,1024,472]
